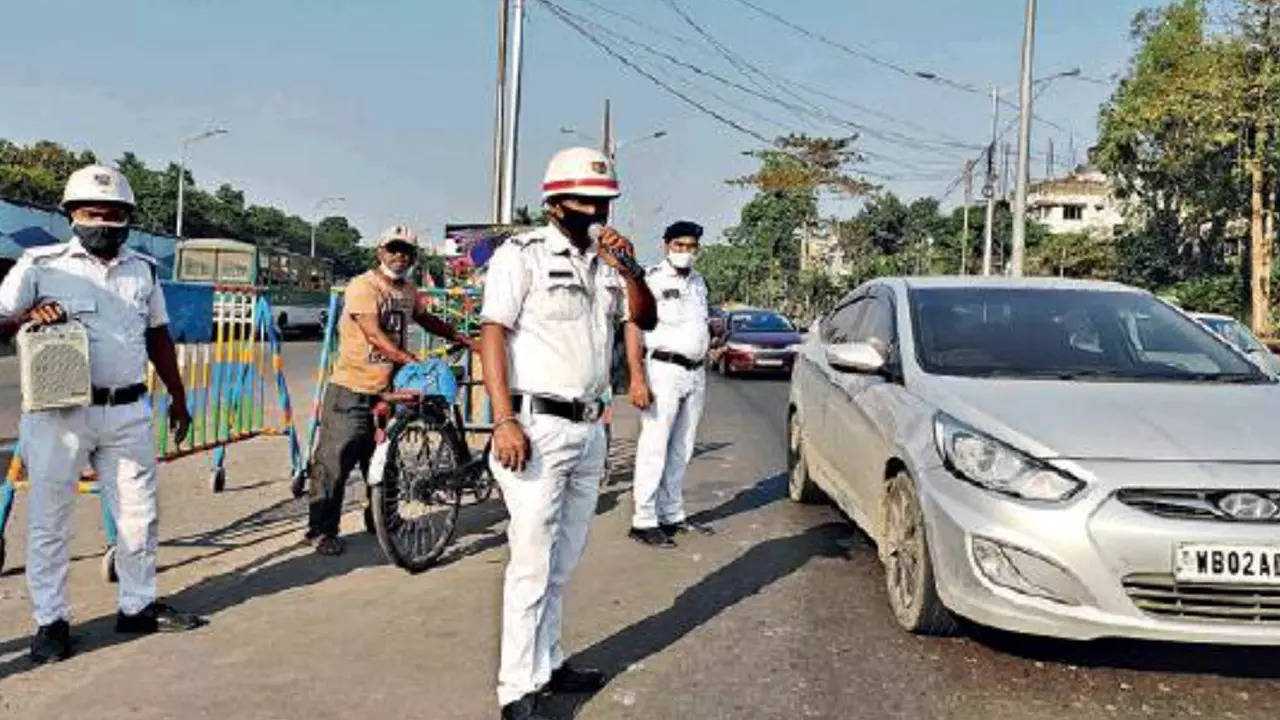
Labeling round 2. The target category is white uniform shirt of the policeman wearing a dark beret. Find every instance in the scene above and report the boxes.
[644,260,712,360]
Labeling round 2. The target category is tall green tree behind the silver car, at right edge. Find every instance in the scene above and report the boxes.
[1097,0,1280,334]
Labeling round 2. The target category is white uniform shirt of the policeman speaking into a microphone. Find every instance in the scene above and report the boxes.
[480,224,627,400]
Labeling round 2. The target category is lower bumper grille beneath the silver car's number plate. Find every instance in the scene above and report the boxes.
[1123,574,1280,624]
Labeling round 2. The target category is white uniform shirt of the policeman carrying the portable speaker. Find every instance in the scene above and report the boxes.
[0,238,169,388]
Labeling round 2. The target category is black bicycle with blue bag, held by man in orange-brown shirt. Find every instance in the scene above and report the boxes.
[367,348,494,573]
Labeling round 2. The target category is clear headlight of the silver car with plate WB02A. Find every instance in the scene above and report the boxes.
[933,413,1084,501]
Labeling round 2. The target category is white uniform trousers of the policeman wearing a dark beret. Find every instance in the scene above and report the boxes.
[631,357,707,529]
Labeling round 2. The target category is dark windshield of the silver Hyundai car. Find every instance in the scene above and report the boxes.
[910,287,1271,383]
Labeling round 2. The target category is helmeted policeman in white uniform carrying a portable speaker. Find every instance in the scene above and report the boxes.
[0,165,202,662]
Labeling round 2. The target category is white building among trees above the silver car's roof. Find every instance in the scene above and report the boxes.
[1027,167,1124,236]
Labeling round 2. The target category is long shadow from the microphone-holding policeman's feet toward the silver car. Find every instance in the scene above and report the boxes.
[553,523,850,717]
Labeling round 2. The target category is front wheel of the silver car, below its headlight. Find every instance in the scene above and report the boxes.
[881,473,959,635]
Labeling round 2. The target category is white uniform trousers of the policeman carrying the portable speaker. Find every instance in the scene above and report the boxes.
[18,400,159,625]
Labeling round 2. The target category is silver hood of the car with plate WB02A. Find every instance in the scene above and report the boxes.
[922,375,1280,462]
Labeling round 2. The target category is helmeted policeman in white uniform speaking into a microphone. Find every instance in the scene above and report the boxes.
[480,147,655,720]
